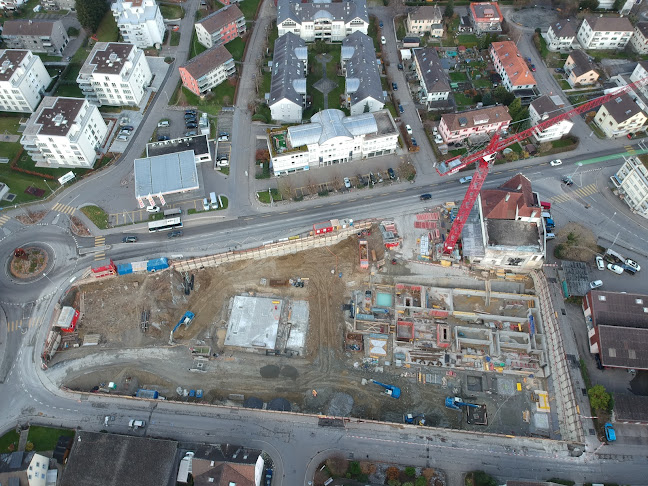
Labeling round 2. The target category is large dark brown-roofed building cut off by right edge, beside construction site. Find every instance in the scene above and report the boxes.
[583,290,648,370]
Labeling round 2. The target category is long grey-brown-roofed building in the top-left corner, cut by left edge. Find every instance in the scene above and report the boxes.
[2,20,70,56]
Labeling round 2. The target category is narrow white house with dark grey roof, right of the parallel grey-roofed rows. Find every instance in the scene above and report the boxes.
[414,48,451,110]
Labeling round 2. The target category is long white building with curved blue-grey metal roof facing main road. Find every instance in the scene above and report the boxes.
[268,109,398,175]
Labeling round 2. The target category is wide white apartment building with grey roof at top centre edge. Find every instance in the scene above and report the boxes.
[277,0,369,42]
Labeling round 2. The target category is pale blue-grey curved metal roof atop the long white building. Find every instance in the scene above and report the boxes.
[288,109,378,147]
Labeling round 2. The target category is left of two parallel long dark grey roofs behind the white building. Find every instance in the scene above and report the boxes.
[268,32,308,106]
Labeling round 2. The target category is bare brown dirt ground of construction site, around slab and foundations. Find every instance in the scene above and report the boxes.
[48,226,558,436]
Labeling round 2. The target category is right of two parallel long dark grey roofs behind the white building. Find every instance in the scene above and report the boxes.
[341,31,385,105]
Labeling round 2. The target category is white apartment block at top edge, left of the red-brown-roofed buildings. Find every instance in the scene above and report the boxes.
[110,0,164,48]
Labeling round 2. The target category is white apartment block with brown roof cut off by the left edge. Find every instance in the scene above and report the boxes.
[0,49,52,113]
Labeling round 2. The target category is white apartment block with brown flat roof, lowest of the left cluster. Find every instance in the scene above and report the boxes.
[20,96,108,168]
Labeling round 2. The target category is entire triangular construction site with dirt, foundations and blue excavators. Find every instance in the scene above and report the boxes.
[43,207,560,438]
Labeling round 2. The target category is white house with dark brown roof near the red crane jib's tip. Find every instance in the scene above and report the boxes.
[594,94,647,138]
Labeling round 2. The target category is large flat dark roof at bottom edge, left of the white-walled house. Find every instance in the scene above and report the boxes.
[59,432,178,486]
